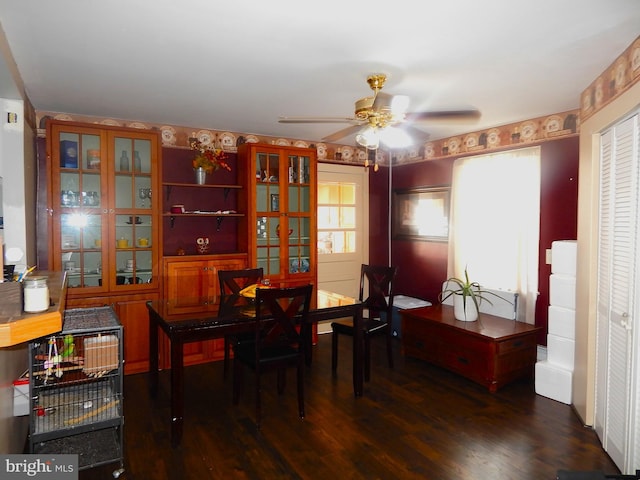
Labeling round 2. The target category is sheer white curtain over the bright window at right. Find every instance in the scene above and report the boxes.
[448,147,540,324]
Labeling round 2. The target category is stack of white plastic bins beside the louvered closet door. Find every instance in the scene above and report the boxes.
[535,240,577,405]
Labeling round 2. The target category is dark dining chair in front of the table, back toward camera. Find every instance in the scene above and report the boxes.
[233,285,313,428]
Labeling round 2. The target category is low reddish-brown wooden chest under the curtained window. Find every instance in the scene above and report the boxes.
[400,305,540,392]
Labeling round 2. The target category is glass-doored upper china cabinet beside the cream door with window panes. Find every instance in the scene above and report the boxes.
[238,143,317,286]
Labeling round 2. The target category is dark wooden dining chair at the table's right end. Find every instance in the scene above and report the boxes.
[331,264,398,382]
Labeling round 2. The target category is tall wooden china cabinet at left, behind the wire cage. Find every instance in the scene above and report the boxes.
[47,120,162,373]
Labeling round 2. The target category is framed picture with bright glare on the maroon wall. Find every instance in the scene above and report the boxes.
[391,186,451,242]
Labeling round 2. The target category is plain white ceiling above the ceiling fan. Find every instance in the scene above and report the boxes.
[0,0,640,143]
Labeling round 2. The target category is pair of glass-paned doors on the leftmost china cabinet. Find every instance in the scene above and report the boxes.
[50,122,158,293]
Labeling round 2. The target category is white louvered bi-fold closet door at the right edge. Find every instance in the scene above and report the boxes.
[595,115,640,472]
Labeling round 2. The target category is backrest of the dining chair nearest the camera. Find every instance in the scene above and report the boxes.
[255,284,313,359]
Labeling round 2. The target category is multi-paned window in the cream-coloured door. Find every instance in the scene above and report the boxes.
[318,182,356,254]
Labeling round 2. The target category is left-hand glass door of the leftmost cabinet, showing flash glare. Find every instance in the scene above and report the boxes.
[54,132,104,288]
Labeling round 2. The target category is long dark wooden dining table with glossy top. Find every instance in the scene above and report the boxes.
[147,290,364,446]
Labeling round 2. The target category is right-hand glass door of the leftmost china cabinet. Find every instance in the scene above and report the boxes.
[109,136,154,289]
